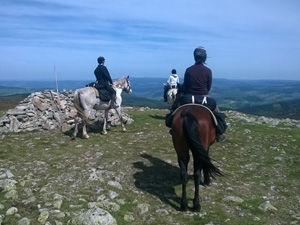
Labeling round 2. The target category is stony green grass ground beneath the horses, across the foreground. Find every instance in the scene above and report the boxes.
[0,108,300,225]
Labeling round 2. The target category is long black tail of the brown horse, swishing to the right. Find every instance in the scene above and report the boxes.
[181,111,223,185]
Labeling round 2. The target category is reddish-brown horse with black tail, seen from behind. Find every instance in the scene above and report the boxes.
[171,104,223,212]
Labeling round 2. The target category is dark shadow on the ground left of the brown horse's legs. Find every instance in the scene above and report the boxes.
[133,154,181,210]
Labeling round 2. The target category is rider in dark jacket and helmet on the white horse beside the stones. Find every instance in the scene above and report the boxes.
[94,56,117,107]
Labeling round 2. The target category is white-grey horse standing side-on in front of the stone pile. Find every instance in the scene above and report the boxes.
[72,76,132,138]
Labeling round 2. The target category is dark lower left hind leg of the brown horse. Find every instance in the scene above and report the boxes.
[178,155,189,211]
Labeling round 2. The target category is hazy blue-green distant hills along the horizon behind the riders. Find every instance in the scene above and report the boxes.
[0,77,300,118]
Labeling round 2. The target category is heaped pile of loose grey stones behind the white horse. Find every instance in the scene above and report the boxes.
[0,90,132,133]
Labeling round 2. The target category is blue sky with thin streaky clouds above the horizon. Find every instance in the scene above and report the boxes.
[0,0,300,81]
